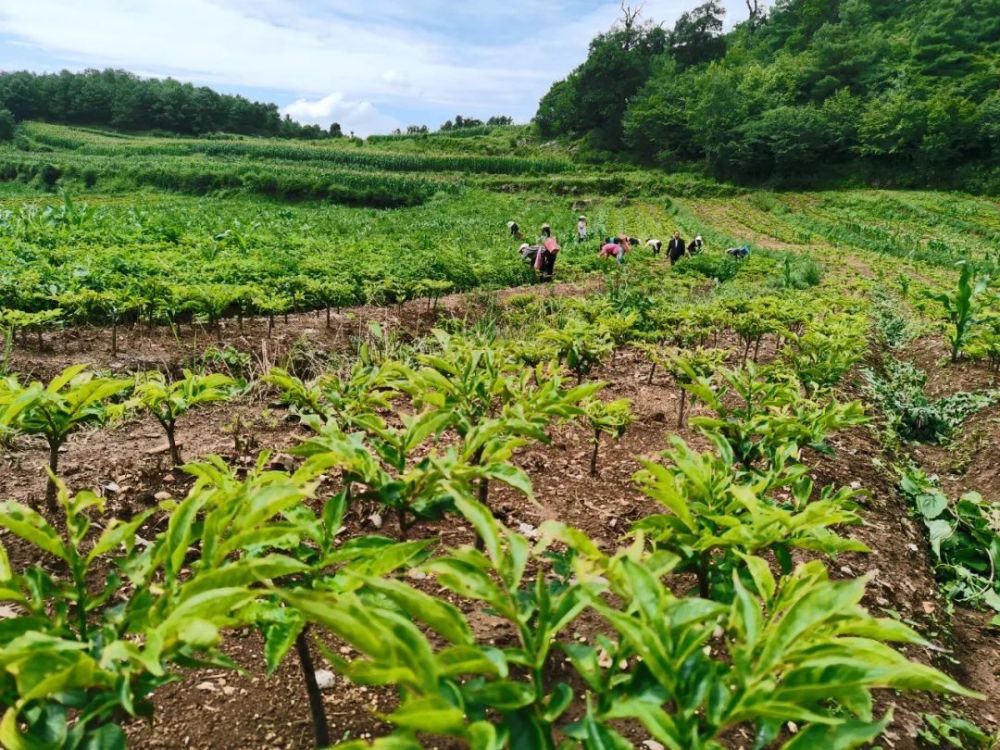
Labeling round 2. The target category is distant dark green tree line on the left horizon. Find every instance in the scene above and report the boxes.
[0,69,341,140]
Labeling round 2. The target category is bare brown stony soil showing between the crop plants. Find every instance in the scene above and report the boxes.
[0,285,1000,750]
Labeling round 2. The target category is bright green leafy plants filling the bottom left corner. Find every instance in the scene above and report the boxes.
[0,456,315,750]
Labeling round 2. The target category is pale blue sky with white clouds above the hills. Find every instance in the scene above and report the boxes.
[0,0,746,135]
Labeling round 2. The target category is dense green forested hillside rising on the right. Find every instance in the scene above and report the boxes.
[536,0,1000,190]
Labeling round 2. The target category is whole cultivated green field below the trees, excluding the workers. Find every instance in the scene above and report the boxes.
[0,122,1000,750]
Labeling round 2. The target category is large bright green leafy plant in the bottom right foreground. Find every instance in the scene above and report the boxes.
[569,556,970,750]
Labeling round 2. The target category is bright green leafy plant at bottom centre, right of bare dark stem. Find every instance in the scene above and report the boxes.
[279,496,585,750]
